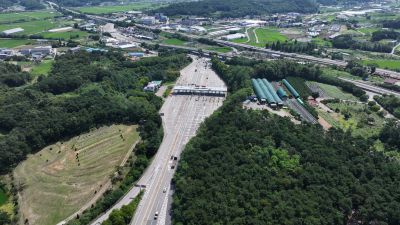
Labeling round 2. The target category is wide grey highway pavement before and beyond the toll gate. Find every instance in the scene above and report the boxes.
[131,59,225,225]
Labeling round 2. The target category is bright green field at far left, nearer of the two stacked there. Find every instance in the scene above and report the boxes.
[0,19,57,35]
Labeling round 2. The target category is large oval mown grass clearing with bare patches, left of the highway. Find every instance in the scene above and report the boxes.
[14,125,139,225]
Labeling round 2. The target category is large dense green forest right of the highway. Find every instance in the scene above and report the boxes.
[172,59,400,225]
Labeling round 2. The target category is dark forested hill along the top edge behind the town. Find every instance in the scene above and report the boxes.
[152,0,318,17]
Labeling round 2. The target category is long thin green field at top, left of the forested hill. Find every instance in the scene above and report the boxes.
[76,2,166,14]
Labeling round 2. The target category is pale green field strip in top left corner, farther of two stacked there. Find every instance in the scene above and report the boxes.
[0,10,61,23]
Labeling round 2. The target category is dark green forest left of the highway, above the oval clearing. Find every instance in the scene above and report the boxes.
[0,52,190,173]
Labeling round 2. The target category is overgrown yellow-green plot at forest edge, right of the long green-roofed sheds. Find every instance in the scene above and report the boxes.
[322,102,384,137]
